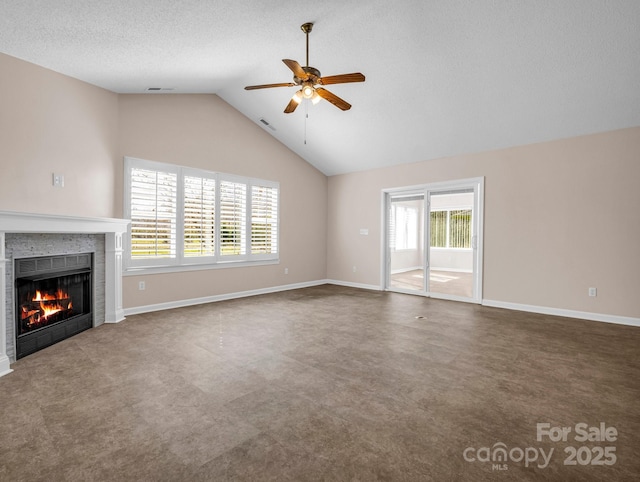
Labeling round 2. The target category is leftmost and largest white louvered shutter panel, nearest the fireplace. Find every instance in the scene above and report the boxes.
[130,168,178,259]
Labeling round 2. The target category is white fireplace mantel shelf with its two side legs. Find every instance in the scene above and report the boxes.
[0,211,130,377]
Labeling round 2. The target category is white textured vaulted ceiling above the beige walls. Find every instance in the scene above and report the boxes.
[0,0,640,175]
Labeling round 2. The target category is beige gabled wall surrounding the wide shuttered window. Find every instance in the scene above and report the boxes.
[117,94,327,308]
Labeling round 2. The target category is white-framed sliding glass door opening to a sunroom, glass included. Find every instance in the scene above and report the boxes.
[383,178,484,303]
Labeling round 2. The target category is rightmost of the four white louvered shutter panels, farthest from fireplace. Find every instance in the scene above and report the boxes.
[251,186,278,254]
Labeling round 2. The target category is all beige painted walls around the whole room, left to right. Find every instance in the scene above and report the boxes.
[0,50,640,317]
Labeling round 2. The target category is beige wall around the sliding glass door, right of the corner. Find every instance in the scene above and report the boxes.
[327,128,640,317]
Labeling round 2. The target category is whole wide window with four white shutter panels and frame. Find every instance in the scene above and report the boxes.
[125,158,280,268]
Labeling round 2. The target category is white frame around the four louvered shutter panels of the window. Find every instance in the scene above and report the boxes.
[123,156,281,274]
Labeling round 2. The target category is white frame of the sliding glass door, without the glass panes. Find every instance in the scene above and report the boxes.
[380,176,484,304]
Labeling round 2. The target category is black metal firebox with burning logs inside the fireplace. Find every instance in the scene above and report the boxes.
[15,253,93,358]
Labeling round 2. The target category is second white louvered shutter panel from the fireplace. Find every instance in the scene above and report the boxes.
[184,176,216,257]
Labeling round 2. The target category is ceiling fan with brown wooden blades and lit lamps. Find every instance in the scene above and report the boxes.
[245,22,364,114]
